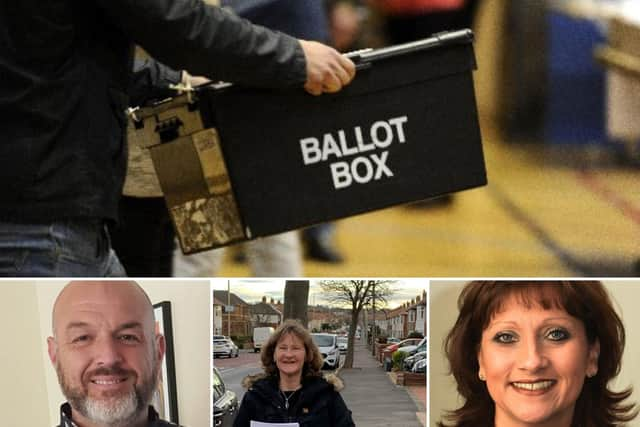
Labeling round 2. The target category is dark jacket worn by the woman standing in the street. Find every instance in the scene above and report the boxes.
[233,375,355,427]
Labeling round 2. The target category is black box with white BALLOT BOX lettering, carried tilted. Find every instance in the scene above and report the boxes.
[129,30,487,253]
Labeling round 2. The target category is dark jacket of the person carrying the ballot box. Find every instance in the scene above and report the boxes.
[0,0,306,222]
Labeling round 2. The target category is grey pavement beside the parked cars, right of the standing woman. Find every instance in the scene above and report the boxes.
[338,343,427,427]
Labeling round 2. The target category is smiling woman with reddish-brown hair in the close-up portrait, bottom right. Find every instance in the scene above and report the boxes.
[438,281,637,427]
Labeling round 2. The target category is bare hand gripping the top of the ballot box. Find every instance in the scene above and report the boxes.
[300,40,356,95]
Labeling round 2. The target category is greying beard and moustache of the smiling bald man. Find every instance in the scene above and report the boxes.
[56,364,158,427]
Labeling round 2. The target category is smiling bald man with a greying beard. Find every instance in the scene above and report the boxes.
[47,281,174,427]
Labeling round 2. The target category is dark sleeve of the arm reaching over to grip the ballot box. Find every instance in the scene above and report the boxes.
[95,0,306,87]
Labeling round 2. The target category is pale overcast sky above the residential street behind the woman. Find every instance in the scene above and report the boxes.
[212,279,427,309]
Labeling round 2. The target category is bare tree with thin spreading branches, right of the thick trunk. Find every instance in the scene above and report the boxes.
[320,280,395,368]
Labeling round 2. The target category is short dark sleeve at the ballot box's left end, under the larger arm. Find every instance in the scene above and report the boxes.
[128,58,182,106]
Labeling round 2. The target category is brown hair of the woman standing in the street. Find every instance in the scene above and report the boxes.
[260,319,324,377]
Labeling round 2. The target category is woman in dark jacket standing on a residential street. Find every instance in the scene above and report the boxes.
[233,320,355,427]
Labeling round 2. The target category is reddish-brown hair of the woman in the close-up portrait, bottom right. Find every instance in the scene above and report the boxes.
[438,281,637,427]
